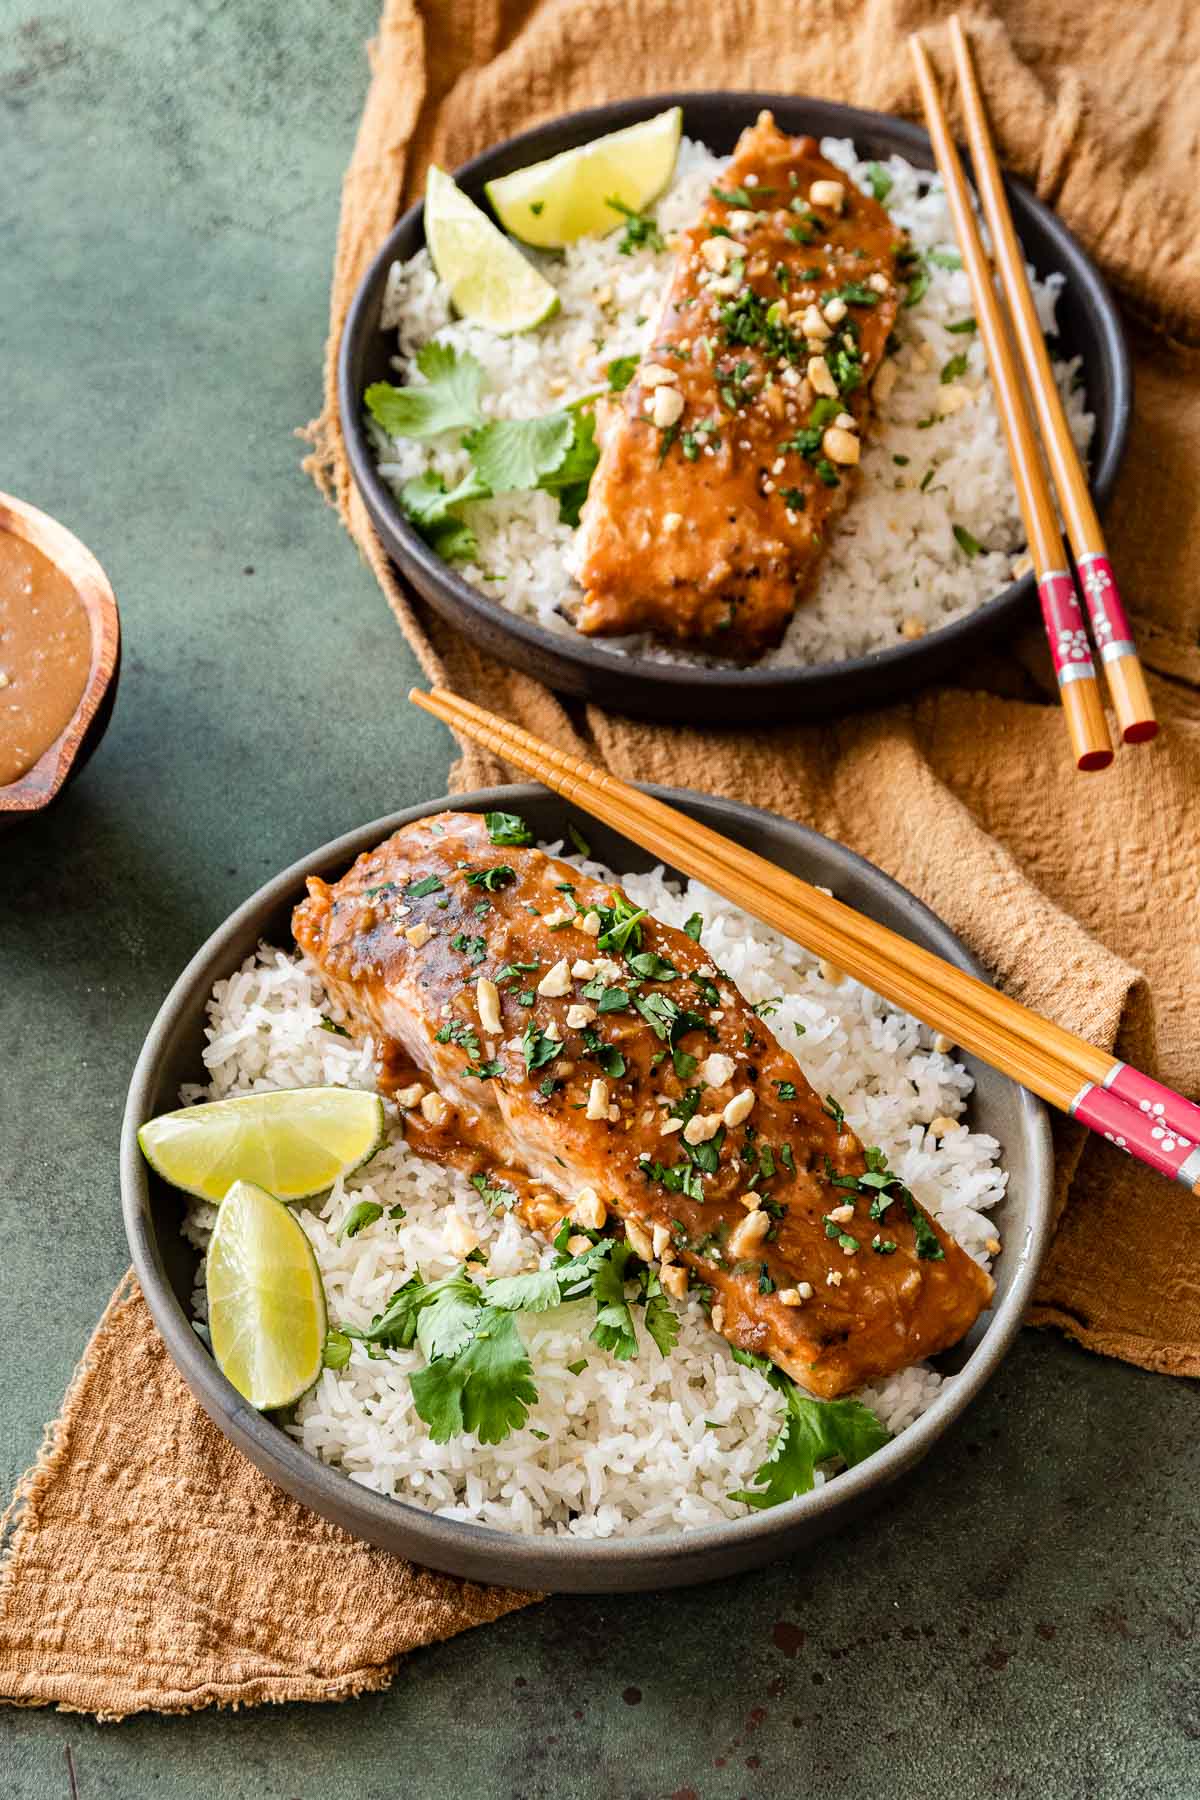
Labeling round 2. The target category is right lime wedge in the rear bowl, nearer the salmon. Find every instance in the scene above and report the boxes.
[486,106,684,250]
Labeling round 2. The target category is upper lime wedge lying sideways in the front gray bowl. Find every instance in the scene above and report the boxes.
[137,1087,385,1204]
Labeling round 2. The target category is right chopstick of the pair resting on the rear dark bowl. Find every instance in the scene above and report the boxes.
[950,13,1159,743]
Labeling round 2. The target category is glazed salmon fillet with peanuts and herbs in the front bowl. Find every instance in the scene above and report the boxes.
[293,812,993,1399]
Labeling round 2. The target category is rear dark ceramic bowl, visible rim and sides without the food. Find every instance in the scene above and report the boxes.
[338,94,1132,725]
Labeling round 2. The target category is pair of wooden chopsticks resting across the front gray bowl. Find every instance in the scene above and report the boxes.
[408,688,1200,1193]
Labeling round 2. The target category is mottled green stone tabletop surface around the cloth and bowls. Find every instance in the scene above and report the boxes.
[0,0,1200,1800]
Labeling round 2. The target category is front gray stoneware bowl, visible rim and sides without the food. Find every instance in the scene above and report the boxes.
[121,787,1051,1593]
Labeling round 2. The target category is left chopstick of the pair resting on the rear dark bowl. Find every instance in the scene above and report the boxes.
[909,38,1112,769]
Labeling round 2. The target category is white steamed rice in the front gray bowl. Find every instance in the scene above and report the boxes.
[184,857,1007,1537]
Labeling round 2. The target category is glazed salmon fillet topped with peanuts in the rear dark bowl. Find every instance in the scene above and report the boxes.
[572,113,901,657]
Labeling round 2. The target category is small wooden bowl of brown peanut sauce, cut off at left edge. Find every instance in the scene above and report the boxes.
[0,493,121,826]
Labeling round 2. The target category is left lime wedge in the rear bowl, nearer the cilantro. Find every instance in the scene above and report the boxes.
[425,166,558,337]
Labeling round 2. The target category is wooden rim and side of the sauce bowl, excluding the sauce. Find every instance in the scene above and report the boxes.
[0,493,121,830]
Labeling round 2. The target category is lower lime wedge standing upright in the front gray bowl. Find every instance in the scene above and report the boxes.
[205,1181,326,1411]
